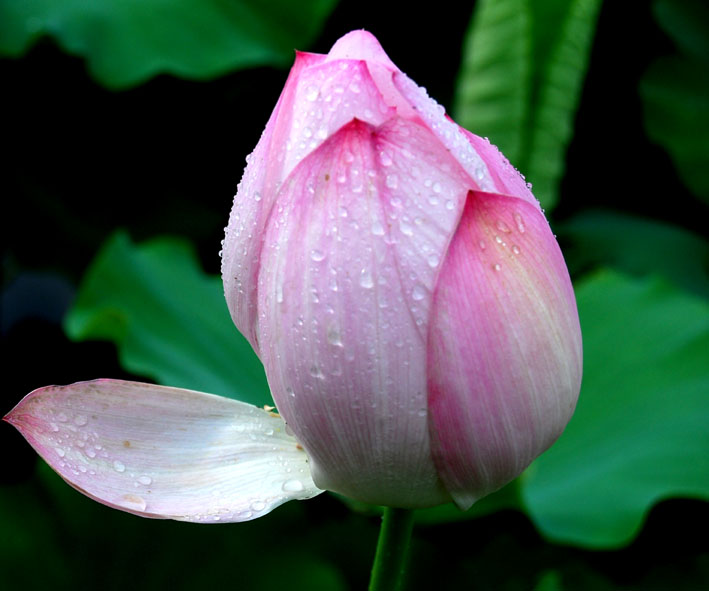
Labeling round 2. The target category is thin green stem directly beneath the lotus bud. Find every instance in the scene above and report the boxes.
[369,507,414,591]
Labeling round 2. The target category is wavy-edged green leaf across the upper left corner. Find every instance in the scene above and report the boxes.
[0,0,336,89]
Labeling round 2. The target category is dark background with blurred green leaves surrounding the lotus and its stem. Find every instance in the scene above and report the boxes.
[0,0,709,591]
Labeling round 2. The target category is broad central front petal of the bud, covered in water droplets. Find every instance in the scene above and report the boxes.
[252,118,478,506]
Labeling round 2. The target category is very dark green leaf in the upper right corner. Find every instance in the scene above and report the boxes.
[640,0,709,202]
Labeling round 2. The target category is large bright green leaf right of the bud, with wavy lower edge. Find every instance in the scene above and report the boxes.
[521,272,709,548]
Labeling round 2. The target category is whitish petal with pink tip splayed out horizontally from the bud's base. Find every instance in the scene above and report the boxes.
[5,380,322,523]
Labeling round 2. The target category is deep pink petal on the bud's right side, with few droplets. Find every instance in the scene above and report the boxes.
[427,191,582,508]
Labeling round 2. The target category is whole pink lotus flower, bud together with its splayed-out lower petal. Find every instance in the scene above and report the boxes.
[5,31,581,523]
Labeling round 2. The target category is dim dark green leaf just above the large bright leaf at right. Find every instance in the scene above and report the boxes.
[555,210,709,298]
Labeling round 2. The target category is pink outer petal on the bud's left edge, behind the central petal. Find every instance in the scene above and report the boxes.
[222,48,394,353]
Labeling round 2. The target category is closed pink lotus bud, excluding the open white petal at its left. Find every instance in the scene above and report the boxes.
[222,31,582,508]
